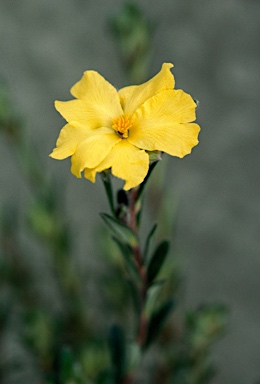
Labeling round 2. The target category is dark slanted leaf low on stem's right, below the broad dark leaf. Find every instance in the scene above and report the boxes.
[144,300,174,348]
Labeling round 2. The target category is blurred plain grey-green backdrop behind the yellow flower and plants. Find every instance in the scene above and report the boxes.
[0,0,260,384]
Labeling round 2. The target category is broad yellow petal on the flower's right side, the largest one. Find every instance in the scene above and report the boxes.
[128,90,200,157]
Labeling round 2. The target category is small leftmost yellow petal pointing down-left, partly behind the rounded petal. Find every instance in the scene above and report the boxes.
[50,124,91,160]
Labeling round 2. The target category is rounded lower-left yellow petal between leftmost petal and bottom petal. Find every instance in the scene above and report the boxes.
[71,128,122,177]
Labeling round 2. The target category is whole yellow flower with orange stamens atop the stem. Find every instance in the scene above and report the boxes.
[50,63,200,190]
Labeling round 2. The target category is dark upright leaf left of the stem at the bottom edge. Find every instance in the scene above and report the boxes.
[108,325,126,383]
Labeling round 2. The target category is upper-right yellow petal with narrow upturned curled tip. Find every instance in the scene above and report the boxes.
[118,63,174,116]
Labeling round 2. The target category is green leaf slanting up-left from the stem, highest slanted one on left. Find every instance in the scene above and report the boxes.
[100,213,138,247]
